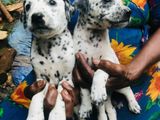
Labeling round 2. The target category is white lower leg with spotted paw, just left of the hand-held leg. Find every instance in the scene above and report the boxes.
[79,88,92,119]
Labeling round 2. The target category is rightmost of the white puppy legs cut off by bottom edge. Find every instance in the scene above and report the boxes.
[104,96,117,120]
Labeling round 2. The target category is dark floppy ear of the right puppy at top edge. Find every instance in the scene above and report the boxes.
[74,0,89,14]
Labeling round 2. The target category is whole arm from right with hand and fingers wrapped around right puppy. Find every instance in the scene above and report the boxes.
[73,28,160,89]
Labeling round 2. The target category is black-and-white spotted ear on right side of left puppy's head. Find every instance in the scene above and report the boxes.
[63,0,74,21]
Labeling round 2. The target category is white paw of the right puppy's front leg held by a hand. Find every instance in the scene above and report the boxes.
[91,85,107,106]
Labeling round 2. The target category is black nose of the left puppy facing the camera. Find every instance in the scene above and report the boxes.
[32,13,45,25]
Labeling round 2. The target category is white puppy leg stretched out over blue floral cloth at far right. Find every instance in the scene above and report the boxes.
[117,87,141,114]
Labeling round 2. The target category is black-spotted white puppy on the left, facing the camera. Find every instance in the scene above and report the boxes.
[23,0,75,120]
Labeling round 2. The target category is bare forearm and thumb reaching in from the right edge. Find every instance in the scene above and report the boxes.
[93,28,160,81]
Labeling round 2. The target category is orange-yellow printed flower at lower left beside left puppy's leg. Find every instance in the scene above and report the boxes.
[11,81,30,108]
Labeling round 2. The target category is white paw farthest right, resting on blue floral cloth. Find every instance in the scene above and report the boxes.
[129,100,141,114]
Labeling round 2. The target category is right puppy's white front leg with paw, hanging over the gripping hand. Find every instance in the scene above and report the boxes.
[91,69,109,106]
